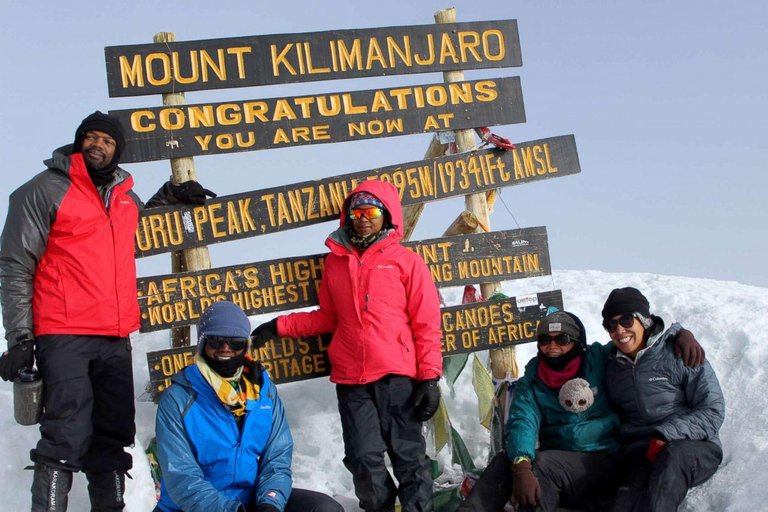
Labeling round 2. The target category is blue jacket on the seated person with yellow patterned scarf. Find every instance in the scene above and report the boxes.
[155,365,293,512]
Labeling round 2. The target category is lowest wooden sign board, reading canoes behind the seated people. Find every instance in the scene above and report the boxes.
[147,290,563,397]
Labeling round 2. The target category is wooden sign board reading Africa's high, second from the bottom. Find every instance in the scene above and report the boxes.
[137,227,552,332]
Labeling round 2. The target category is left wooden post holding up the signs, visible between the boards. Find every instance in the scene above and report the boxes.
[152,32,211,348]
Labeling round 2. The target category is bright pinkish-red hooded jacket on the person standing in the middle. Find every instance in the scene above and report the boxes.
[277,180,442,384]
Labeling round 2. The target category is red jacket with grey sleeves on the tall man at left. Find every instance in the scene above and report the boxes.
[0,146,143,336]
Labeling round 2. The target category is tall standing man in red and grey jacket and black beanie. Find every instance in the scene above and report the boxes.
[0,111,216,512]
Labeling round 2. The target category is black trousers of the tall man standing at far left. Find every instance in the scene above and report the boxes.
[31,334,136,473]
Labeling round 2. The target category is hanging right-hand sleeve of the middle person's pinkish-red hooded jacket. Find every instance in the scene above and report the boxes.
[407,256,443,380]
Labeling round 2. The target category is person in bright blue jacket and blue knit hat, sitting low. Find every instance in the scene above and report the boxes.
[155,301,343,512]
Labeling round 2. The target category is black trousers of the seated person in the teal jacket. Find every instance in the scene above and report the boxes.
[456,450,620,512]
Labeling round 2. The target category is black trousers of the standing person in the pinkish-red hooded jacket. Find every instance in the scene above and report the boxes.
[336,375,433,512]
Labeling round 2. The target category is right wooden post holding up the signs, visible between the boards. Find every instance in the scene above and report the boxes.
[435,7,517,379]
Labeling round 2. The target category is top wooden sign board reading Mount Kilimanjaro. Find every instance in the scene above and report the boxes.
[104,20,522,97]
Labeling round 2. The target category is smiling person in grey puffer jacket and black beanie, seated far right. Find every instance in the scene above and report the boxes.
[602,287,725,512]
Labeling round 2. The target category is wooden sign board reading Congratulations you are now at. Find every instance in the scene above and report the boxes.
[110,77,525,163]
